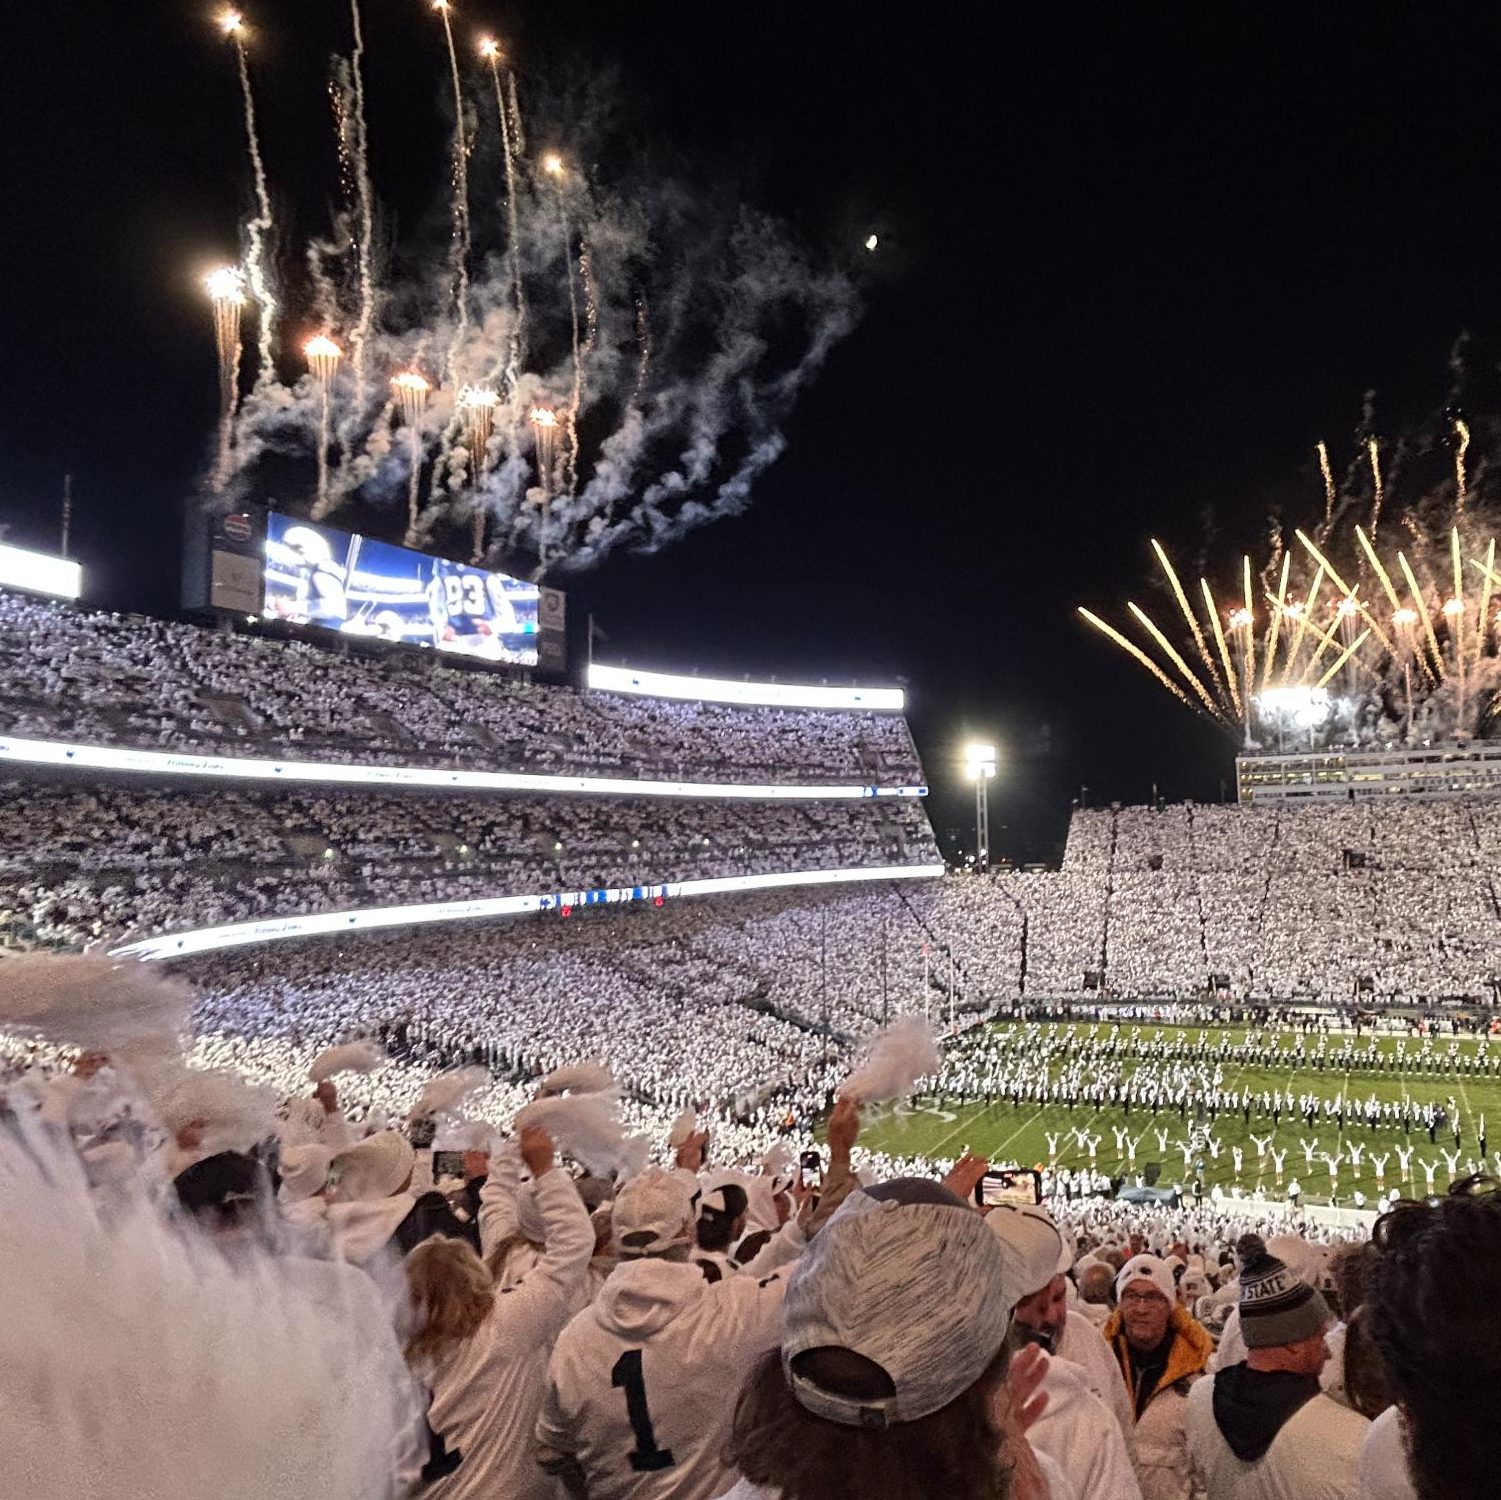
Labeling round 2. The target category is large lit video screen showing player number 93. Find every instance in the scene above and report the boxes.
[261,512,540,667]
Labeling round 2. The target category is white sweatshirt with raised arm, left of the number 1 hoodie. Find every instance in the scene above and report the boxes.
[419,1168,594,1500]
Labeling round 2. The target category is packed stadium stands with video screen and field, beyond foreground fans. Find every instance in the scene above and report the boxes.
[0,514,1501,1219]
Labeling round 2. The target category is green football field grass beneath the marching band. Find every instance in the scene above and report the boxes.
[860,1023,1501,1204]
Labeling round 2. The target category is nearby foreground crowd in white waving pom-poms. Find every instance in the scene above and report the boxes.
[0,958,1501,1500]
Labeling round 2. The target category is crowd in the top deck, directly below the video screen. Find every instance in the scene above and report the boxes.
[0,590,920,785]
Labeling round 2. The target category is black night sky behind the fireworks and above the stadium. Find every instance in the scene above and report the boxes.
[0,0,1501,854]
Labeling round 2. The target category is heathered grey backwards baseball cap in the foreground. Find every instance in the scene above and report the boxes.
[782,1182,1016,1428]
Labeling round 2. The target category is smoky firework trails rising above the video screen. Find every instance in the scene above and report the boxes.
[206,23,858,573]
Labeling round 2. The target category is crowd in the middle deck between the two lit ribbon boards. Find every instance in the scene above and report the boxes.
[0,779,938,944]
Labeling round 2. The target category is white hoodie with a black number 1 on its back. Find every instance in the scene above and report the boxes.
[537,1260,787,1500]
